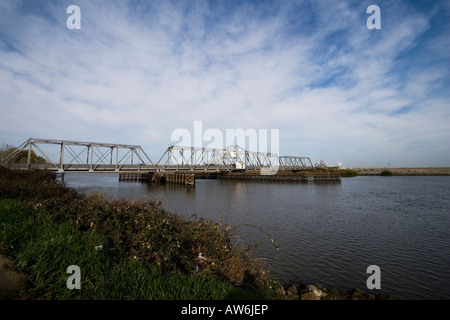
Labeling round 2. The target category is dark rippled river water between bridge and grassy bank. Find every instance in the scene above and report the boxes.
[61,173,450,299]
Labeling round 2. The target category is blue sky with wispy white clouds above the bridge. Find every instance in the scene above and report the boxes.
[0,0,450,167]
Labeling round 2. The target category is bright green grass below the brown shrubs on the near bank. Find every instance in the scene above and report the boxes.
[0,199,270,299]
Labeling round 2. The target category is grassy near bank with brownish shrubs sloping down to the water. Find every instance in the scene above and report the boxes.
[0,167,278,299]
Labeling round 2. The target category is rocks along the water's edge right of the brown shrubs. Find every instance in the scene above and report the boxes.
[282,281,396,300]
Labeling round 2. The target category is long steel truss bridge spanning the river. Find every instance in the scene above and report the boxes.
[2,138,314,174]
